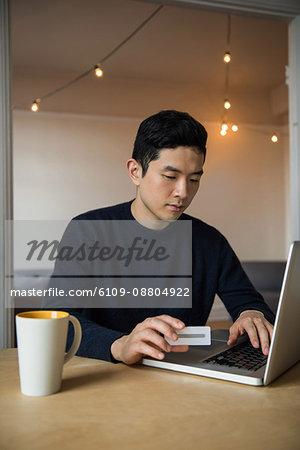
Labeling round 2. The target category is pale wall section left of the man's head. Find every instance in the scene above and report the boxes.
[13,112,140,220]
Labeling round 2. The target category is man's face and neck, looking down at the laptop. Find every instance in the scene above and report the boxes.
[132,147,204,220]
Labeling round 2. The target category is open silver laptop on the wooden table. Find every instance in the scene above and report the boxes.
[141,241,300,386]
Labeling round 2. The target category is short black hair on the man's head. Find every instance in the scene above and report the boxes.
[132,110,207,176]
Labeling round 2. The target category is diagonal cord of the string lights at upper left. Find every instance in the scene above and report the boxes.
[12,5,163,109]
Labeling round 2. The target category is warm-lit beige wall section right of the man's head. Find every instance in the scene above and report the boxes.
[189,124,289,260]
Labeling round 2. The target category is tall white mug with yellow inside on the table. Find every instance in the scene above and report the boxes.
[16,311,82,396]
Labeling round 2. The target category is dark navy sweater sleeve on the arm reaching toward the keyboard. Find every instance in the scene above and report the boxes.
[217,236,275,323]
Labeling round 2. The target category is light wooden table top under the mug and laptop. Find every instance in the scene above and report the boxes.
[0,349,300,450]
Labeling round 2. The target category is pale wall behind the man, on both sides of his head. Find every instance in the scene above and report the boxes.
[13,111,289,260]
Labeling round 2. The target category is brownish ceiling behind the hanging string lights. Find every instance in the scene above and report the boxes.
[11,0,288,123]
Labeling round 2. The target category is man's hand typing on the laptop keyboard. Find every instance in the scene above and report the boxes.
[227,310,273,355]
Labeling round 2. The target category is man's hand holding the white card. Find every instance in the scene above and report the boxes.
[110,314,188,364]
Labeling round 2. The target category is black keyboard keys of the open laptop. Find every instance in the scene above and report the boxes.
[202,341,268,371]
